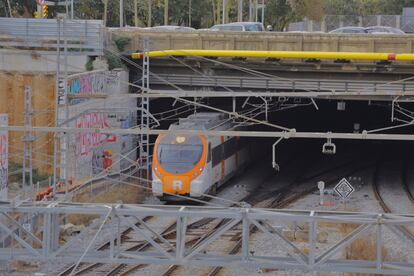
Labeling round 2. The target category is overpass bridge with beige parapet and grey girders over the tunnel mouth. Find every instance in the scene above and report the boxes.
[106,28,414,103]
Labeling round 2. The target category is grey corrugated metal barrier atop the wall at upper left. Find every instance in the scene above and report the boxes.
[0,18,104,55]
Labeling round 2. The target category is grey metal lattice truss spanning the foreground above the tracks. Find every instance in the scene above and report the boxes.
[0,202,414,275]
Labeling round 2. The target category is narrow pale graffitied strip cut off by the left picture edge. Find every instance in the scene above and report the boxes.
[0,114,9,200]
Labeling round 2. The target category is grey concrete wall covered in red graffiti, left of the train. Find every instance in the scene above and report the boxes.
[62,71,137,182]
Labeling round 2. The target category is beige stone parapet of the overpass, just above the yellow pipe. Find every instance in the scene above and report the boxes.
[107,28,414,57]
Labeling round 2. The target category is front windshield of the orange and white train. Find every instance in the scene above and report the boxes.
[157,137,203,174]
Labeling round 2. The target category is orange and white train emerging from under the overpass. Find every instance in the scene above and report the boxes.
[152,113,250,199]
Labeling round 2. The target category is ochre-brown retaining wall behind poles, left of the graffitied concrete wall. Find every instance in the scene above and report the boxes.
[0,71,55,173]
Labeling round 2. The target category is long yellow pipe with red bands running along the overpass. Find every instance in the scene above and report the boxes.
[132,49,414,61]
